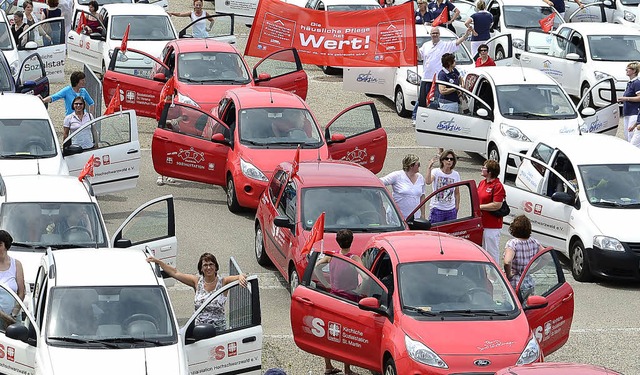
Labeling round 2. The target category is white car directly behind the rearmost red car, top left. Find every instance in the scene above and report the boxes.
[67,4,178,73]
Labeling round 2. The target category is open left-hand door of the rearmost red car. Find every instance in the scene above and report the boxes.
[102,48,171,119]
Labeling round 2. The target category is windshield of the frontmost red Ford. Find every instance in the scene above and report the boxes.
[398,262,518,316]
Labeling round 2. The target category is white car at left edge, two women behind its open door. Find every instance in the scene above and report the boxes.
[0,94,140,194]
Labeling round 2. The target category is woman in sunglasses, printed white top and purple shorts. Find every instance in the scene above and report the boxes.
[425,150,460,224]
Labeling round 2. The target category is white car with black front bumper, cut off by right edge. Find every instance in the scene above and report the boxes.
[501,134,640,281]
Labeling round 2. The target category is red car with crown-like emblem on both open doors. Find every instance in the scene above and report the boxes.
[151,87,387,212]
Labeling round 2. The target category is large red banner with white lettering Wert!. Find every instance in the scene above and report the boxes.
[244,0,417,67]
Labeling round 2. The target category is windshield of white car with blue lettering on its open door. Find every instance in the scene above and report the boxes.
[496,85,578,120]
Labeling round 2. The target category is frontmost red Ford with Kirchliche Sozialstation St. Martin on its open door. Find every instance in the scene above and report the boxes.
[290,231,574,375]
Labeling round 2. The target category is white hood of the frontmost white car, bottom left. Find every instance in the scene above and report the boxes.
[48,344,185,375]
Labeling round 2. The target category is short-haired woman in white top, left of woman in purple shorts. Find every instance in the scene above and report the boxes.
[380,154,426,219]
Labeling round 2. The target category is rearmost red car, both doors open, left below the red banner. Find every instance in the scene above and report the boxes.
[102,38,308,118]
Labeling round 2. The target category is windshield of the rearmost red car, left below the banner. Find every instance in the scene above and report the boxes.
[178,52,251,85]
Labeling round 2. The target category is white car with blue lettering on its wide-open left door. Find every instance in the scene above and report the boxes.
[416,66,619,164]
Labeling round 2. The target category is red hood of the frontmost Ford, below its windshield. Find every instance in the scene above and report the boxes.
[400,313,531,356]
